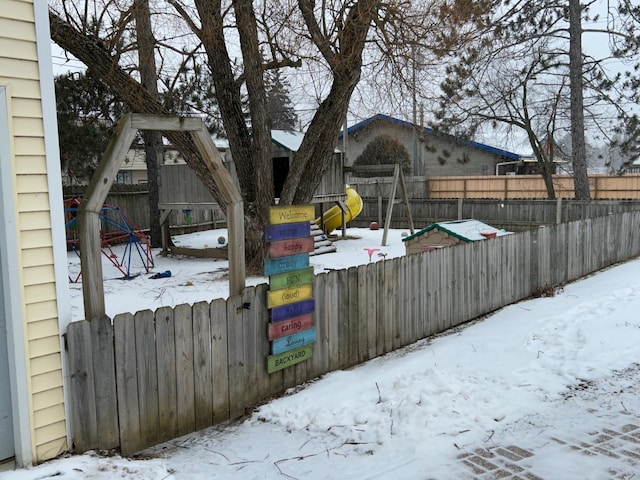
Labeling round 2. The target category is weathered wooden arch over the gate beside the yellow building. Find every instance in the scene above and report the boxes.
[78,113,245,320]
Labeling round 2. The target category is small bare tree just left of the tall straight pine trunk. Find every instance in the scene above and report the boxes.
[434,37,570,199]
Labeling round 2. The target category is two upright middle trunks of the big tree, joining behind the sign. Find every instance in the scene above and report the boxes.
[190,0,275,274]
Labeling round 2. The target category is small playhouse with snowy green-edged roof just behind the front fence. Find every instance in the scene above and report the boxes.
[402,219,512,255]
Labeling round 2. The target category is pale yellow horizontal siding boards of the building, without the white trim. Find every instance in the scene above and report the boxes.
[0,0,67,462]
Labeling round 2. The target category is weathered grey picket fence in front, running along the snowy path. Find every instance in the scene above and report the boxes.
[66,212,640,455]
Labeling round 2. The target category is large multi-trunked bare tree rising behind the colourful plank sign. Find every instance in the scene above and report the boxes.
[50,0,484,271]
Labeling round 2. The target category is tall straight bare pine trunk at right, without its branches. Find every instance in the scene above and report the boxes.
[569,0,591,200]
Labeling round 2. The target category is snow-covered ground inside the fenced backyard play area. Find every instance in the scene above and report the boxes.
[68,228,408,321]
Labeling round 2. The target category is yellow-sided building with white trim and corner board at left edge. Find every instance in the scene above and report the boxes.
[0,0,71,464]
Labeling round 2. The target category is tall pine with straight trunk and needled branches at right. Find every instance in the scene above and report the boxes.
[432,0,640,199]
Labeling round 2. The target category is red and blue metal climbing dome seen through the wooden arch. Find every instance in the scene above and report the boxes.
[64,198,154,283]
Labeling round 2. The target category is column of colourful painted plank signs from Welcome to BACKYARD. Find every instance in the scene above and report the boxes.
[264,205,316,373]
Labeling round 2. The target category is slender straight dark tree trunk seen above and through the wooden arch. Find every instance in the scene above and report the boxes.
[133,0,164,248]
